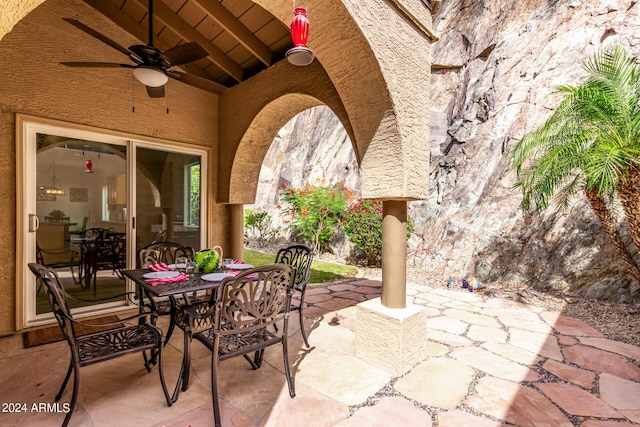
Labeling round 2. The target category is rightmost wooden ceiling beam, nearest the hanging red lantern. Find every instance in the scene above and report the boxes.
[189,0,273,67]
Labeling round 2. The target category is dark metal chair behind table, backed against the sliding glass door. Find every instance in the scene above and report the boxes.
[137,242,197,342]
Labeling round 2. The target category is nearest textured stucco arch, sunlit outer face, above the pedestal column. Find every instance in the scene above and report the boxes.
[255,0,433,200]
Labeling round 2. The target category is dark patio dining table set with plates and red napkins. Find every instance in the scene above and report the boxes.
[122,268,230,402]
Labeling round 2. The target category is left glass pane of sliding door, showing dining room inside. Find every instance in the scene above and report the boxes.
[35,133,128,314]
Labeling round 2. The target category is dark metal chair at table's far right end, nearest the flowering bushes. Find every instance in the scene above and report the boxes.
[275,245,313,348]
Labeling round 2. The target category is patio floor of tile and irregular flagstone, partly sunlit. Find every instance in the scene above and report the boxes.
[0,279,640,427]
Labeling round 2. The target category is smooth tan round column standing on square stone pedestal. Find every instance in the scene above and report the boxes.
[381,200,407,308]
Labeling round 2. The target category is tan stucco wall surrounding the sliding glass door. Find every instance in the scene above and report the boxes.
[0,0,220,335]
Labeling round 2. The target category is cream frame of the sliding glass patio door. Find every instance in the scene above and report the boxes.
[15,113,211,331]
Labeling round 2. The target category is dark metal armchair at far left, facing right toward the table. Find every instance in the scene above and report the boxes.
[29,263,173,427]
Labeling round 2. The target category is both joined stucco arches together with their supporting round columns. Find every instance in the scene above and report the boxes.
[218,0,434,308]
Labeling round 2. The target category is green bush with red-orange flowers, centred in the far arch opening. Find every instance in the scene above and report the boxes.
[282,184,351,254]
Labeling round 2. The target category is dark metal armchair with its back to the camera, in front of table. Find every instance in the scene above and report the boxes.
[175,264,295,427]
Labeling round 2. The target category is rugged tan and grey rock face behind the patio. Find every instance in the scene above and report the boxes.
[252,0,640,301]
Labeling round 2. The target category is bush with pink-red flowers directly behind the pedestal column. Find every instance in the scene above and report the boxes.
[342,199,413,265]
